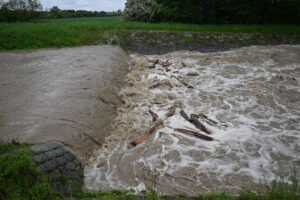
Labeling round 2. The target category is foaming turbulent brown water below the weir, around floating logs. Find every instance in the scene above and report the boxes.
[85,45,300,195]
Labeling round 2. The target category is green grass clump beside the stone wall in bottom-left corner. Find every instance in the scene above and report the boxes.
[0,141,59,200]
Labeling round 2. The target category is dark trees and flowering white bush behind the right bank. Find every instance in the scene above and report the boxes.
[124,0,300,24]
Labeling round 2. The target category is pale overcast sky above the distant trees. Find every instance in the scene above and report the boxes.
[40,0,126,11]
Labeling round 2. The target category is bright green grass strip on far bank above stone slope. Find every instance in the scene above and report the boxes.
[0,17,300,51]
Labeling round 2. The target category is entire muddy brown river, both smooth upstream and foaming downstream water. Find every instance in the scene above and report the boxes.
[0,45,300,196]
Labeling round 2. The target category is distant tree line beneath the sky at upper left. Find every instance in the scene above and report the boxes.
[0,0,121,22]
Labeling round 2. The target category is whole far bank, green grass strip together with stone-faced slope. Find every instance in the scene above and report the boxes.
[0,17,300,52]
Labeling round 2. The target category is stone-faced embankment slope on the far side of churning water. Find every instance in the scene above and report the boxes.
[113,30,300,55]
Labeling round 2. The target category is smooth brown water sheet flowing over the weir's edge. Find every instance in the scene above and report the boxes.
[0,46,129,160]
